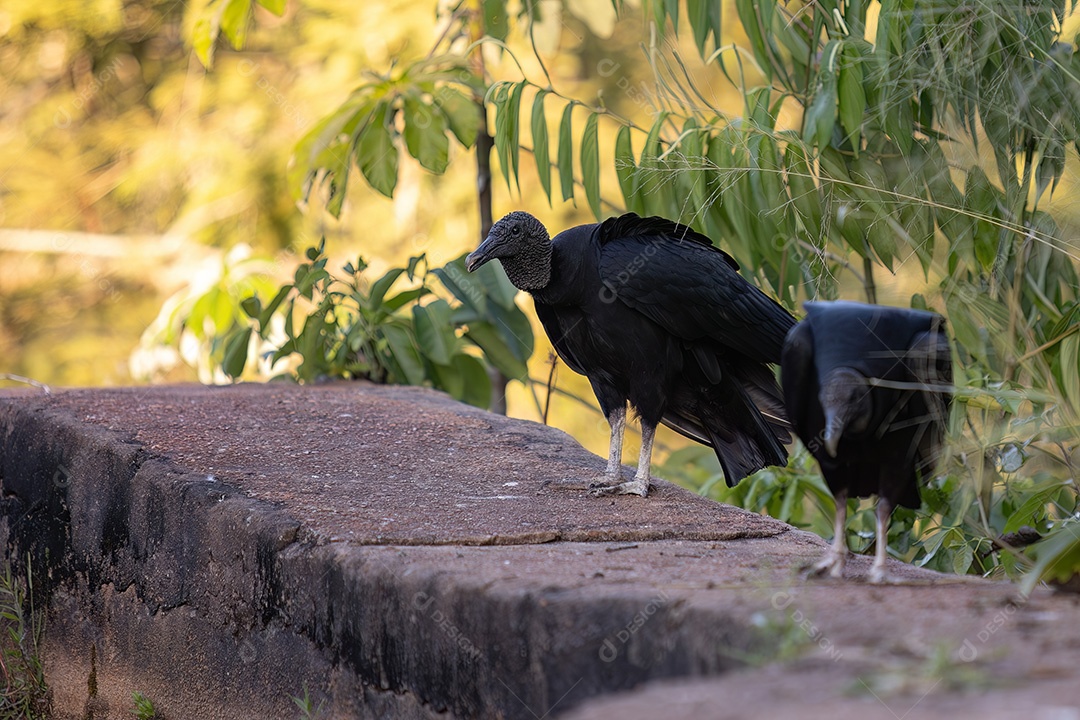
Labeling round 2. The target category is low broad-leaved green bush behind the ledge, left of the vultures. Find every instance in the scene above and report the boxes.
[219,243,532,408]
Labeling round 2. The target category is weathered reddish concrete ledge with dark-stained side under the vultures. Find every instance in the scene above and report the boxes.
[0,383,1080,720]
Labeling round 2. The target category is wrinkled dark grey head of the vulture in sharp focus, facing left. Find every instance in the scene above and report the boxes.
[465,210,551,290]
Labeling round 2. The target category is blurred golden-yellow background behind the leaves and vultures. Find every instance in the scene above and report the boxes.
[0,0,1077,458]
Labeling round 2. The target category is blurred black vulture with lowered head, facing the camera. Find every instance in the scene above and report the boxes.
[781,301,953,583]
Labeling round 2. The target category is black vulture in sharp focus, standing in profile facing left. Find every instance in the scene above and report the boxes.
[465,212,795,497]
